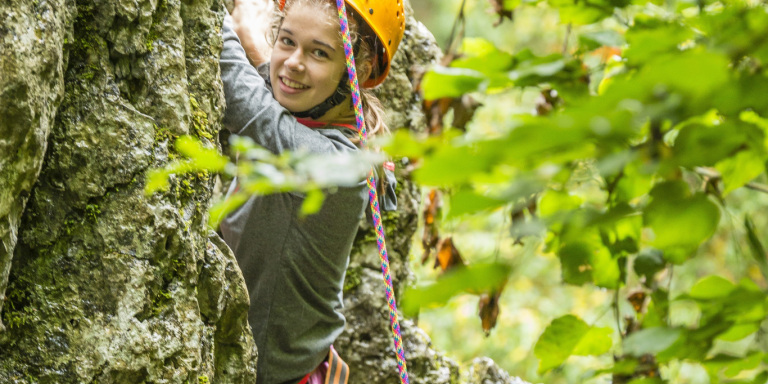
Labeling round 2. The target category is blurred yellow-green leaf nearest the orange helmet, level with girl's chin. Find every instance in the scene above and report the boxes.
[421,66,488,100]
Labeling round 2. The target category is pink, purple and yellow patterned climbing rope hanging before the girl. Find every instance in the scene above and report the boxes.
[336,0,410,384]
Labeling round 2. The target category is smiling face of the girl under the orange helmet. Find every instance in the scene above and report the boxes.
[269,5,346,112]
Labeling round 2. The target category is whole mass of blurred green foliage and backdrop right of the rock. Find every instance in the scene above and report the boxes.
[412,0,768,383]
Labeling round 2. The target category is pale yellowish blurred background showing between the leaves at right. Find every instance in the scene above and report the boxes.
[411,0,768,384]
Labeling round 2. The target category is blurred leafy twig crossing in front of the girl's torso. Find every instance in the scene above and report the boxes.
[145,135,382,228]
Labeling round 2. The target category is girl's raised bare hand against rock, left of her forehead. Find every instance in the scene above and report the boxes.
[231,0,275,67]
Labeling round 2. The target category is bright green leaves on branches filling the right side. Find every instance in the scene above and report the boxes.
[400,0,768,383]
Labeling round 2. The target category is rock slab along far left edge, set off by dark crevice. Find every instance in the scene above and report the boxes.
[0,0,72,332]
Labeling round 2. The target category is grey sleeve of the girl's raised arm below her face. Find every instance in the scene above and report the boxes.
[219,14,350,153]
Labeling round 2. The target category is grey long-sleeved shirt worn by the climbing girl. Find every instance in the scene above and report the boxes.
[220,15,368,384]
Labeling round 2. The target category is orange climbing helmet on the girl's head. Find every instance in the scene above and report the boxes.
[279,0,405,88]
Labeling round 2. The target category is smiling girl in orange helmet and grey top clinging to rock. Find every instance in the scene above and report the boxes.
[220,0,404,384]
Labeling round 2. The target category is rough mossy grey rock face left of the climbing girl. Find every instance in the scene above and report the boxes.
[0,0,256,383]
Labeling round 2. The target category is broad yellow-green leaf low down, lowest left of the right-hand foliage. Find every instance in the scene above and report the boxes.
[533,315,613,373]
